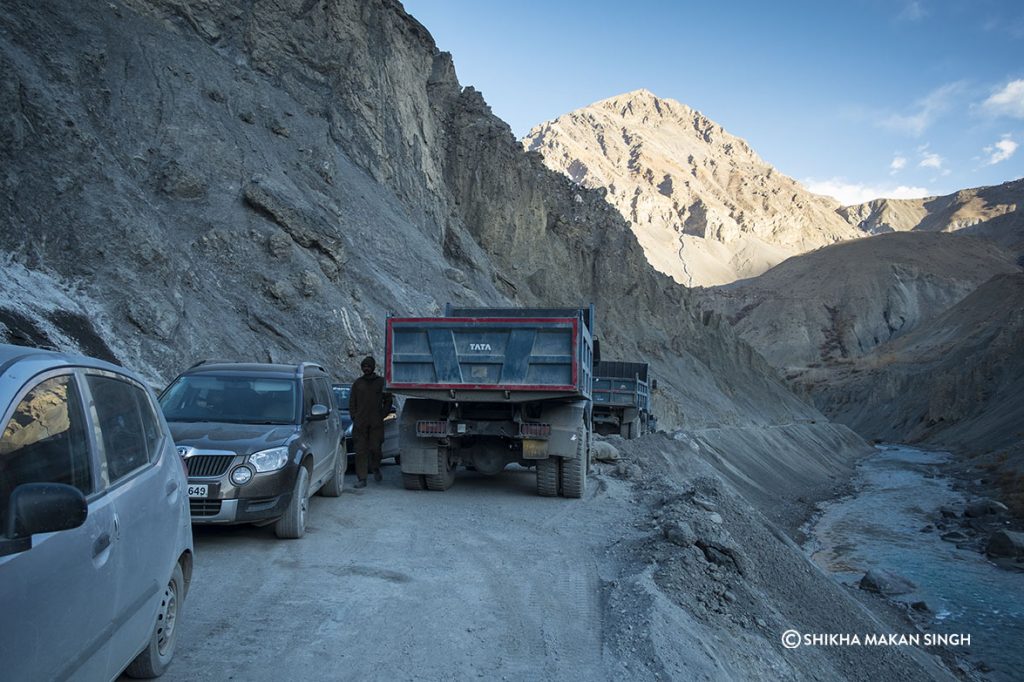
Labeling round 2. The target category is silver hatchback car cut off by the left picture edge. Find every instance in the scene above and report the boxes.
[0,344,193,680]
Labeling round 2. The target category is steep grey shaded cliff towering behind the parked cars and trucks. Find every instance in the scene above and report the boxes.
[0,0,821,436]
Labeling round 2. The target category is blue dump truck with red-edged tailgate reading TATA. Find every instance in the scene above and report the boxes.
[384,305,594,498]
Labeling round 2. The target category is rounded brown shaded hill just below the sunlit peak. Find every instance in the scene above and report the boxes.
[697,233,1020,372]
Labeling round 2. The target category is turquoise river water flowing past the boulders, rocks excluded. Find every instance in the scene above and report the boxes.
[806,445,1024,680]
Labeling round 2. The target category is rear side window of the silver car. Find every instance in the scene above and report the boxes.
[86,375,160,483]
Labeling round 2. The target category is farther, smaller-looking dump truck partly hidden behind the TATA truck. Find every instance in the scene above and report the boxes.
[593,360,657,438]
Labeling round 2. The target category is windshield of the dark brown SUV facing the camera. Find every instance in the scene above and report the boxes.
[160,375,299,424]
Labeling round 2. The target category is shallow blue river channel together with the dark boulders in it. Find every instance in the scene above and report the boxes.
[805,444,1024,681]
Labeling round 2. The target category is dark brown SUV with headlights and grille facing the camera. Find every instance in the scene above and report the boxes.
[160,363,345,538]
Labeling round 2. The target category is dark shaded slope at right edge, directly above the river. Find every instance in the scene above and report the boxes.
[795,271,1024,509]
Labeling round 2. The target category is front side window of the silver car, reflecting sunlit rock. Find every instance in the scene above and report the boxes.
[0,375,95,528]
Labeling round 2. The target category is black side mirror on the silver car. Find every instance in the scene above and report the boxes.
[0,483,89,556]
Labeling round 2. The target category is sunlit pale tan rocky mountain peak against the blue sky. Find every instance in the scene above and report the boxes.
[523,90,863,286]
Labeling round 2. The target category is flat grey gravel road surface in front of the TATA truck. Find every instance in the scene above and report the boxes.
[155,466,631,682]
